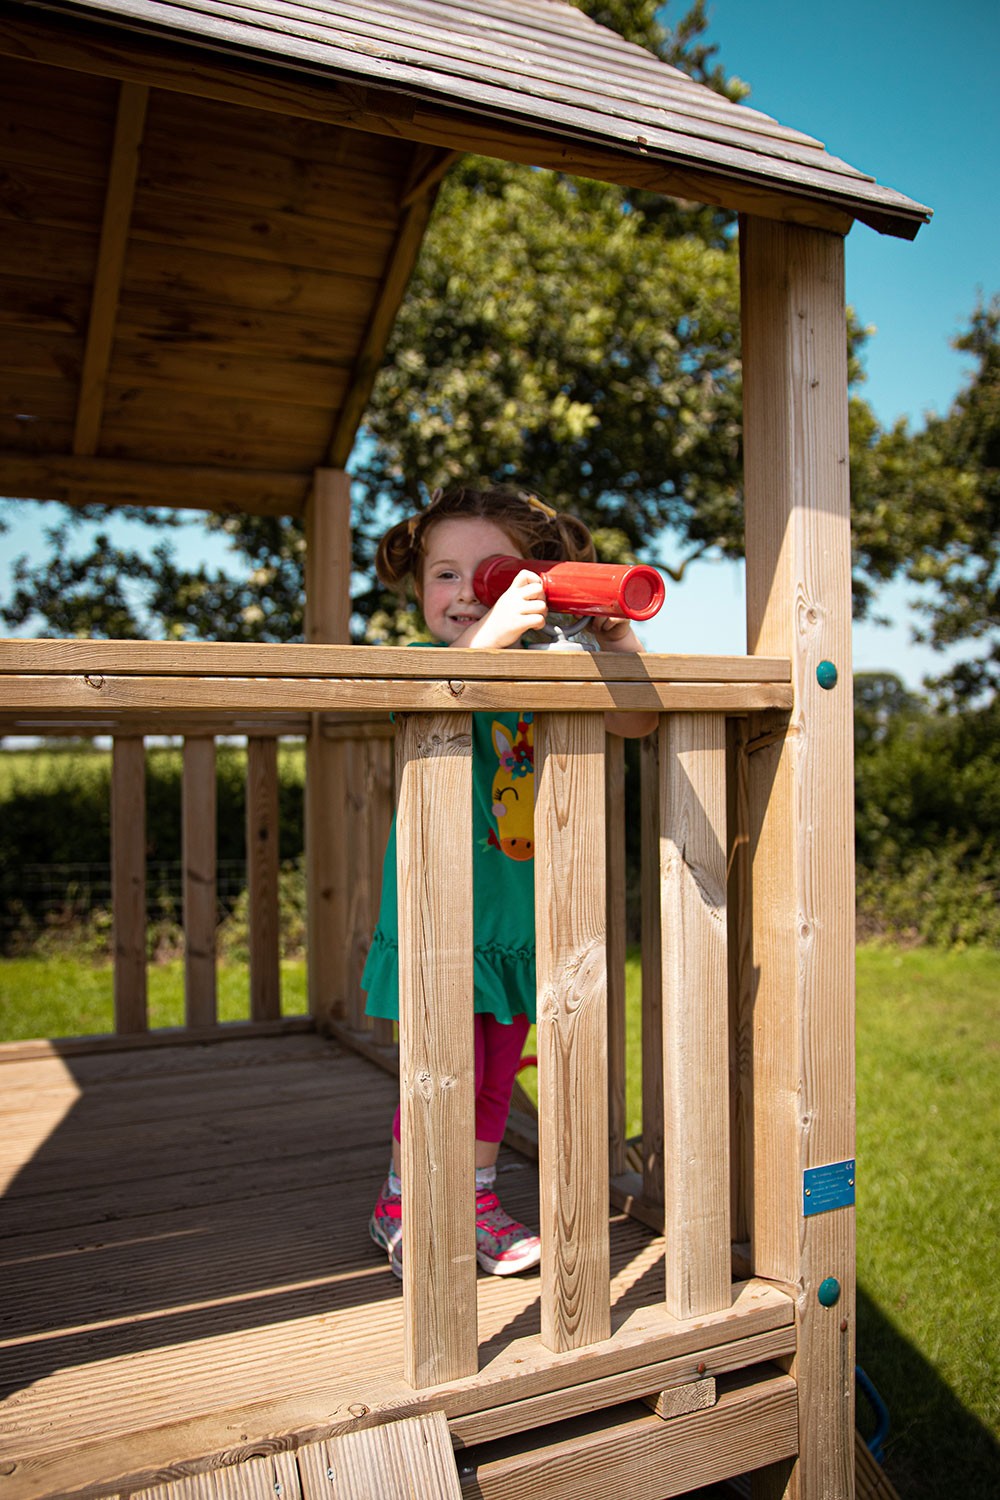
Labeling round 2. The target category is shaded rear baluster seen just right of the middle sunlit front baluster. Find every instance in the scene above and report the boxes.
[604,735,627,1178]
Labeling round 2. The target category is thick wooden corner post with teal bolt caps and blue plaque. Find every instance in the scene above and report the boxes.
[741,218,855,1500]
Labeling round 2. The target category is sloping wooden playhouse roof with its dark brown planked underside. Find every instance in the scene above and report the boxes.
[0,0,928,513]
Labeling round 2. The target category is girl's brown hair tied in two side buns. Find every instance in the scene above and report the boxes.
[375,485,597,594]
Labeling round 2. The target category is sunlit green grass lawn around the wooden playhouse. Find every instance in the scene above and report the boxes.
[0,947,1000,1500]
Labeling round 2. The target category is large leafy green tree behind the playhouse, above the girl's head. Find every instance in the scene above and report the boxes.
[3,0,755,639]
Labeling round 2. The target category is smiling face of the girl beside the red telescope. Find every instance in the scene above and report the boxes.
[417,516,523,645]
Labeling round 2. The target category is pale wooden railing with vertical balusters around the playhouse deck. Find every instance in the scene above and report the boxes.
[0,642,792,1388]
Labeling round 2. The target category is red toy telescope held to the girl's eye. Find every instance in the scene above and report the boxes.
[472,554,666,620]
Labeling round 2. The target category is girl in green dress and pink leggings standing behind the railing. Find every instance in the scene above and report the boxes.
[361,489,657,1277]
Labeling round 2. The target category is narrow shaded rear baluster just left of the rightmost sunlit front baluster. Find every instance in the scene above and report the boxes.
[639,719,663,1206]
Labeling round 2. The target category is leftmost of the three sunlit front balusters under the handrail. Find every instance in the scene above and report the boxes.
[396,714,478,1388]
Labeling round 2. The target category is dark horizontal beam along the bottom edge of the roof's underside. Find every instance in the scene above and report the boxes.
[0,450,312,516]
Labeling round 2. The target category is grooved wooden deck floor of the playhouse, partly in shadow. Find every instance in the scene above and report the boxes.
[0,1035,790,1500]
